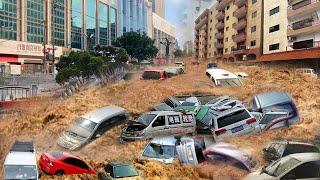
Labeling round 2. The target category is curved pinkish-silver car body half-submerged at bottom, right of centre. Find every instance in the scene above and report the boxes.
[205,143,257,172]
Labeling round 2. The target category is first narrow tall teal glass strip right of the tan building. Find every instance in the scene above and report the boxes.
[71,0,83,49]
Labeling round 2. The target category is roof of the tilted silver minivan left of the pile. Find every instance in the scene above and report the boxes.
[81,106,127,124]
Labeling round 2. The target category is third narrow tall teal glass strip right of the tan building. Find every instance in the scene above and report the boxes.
[99,2,109,45]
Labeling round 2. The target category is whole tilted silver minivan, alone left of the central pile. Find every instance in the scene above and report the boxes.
[58,106,129,150]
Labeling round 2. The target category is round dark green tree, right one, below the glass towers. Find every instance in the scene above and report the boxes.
[113,32,158,62]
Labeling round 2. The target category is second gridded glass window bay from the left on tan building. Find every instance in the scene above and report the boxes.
[26,0,44,43]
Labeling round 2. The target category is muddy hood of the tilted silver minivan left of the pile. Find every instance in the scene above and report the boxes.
[57,132,86,150]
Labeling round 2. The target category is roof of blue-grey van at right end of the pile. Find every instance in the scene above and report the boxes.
[256,92,292,108]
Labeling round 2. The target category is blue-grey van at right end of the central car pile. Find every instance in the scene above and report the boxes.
[251,92,300,130]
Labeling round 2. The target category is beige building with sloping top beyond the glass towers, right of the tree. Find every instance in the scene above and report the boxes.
[152,13,176,59]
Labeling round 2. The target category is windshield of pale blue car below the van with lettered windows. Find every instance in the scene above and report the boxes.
[143,143,174,159]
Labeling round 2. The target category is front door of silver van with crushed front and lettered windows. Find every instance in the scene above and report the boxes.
[148,115,170,137]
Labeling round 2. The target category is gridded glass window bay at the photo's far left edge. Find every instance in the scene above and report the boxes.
[0,0,17,40]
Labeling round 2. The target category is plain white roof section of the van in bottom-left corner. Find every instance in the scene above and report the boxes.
[4,151,37,165]
